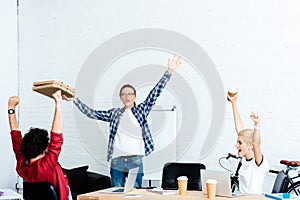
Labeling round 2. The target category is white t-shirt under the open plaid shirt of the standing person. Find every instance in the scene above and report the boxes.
[112,109,145,158]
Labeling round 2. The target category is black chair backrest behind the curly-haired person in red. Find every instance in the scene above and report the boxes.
[23,181,59,200]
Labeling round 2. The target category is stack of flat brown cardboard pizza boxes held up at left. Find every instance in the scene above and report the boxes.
[32,80,75,98]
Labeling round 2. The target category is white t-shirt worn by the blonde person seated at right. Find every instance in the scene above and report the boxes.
[239,158,269,194]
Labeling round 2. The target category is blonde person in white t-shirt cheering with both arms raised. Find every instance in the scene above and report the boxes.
[227,92,269,194]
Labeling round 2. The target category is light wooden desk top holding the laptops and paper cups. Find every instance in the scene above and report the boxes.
[77,189,269,200]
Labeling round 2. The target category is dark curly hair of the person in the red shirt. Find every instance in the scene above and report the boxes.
[21,128,49,160]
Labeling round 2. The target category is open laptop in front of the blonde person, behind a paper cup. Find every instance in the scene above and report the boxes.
[200,170,243,197]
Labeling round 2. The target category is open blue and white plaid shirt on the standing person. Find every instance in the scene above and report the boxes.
[74,72,172,161]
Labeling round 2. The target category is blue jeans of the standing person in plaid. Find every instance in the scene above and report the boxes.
[110,156,144,188]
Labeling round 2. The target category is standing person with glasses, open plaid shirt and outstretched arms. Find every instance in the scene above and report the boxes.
[63,55,181,188]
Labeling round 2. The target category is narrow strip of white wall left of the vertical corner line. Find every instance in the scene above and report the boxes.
[0,0,18,188]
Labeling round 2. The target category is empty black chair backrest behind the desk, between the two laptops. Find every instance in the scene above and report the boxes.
[161,162,205,190]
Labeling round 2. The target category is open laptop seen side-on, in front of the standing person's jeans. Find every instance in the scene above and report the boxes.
[100,167,139,194]
